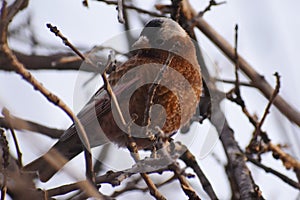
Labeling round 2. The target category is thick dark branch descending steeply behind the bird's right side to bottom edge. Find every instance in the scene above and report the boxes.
[177,1,262,199]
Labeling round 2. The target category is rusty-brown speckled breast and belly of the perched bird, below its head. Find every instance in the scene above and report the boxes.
[110,50,202,138]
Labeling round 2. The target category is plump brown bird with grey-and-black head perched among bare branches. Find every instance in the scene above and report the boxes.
[24,17,202,182]
